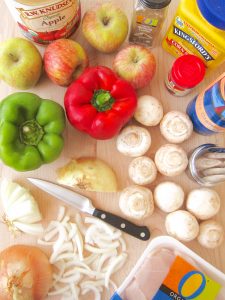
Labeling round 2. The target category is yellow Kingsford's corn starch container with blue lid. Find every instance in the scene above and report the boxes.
[162,0,225,68]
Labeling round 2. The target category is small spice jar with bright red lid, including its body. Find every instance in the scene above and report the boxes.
[165,54,205,96]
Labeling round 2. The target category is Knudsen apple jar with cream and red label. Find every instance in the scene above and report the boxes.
[5,0,81,44]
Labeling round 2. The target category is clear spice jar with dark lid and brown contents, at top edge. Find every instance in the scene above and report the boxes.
[129,0,171,47]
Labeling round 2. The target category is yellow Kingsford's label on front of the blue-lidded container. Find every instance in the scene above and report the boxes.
[163,15,222,66]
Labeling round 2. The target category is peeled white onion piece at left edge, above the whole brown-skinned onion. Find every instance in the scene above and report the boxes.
[0,179,43,235]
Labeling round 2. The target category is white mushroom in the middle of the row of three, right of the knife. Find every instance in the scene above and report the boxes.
[154,181,184,213]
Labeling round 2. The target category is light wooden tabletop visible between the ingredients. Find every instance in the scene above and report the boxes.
[0,0,225,300]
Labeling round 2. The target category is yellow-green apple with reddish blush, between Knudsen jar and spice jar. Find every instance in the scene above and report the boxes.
[82,3,128,53]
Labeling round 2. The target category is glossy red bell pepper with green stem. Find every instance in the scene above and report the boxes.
[64,66,137,140]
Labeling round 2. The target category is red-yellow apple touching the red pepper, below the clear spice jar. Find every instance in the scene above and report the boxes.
[113,45,156,89]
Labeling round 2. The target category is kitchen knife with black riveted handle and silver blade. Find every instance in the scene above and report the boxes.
[27,178,150,241]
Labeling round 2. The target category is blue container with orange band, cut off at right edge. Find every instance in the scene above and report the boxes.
[187,72,225,135]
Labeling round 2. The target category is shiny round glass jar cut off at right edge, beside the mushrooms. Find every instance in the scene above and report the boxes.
[189,144,225,186]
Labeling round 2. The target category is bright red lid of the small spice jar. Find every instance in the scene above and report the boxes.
[171,54,205,88]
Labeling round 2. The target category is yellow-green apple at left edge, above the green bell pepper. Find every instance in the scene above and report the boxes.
[0,38,42,90]
